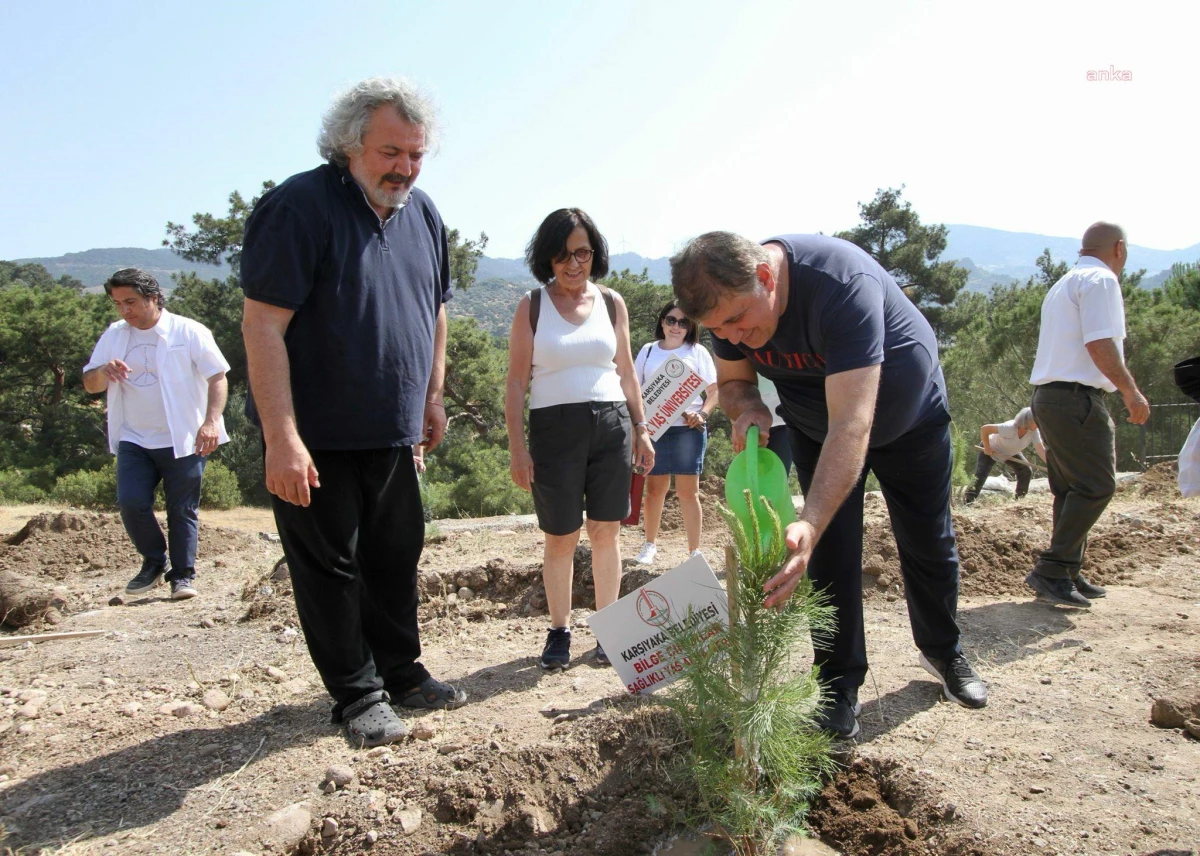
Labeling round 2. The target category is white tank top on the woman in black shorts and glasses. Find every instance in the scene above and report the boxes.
[529,282,625,409]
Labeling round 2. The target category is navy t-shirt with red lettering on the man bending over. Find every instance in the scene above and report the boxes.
[713,235,948,448]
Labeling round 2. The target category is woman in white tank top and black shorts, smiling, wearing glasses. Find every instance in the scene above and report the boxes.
[504,208,654,670]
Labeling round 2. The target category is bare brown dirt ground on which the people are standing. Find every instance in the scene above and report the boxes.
[0,471,1200,856]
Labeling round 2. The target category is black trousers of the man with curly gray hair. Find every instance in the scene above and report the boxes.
[271,445,430,722]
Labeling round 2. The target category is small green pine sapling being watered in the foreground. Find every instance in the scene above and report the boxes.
[665,491,833,856]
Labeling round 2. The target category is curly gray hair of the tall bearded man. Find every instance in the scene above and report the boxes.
[317,77,442,167]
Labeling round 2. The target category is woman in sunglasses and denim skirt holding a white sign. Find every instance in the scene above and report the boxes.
[634,300,716,564]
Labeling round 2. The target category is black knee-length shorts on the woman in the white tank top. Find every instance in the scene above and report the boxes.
[529,401,634,535]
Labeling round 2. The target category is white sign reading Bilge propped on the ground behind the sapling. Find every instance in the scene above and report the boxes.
[588,556,730,695]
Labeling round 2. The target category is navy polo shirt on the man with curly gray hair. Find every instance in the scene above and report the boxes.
[241,163,451,449]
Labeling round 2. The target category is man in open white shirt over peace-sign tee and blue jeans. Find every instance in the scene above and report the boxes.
[83,268,229,600]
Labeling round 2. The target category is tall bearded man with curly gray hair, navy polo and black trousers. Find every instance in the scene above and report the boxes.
[241,78,467,746]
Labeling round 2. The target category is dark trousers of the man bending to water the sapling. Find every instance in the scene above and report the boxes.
[788,417,962,689]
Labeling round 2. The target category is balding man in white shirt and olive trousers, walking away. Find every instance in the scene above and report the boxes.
[1025,222,1150,606]
